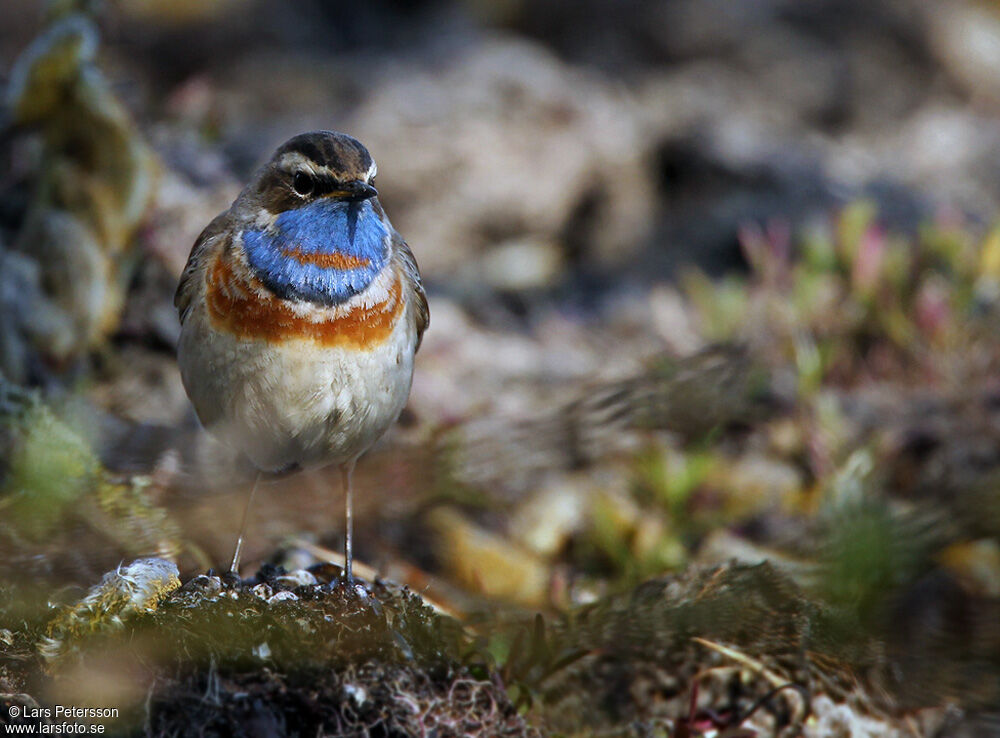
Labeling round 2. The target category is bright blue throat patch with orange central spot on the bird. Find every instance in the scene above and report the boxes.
[243,198,389,305]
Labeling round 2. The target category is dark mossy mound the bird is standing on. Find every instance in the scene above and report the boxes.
[35,560,536,736]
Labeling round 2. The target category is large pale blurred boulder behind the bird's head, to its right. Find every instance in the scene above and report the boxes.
[345,37,653,284]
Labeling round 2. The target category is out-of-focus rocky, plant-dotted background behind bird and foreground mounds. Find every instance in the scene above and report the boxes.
[0,0,1000,734]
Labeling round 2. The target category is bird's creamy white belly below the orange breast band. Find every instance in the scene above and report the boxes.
[178,300,416,471]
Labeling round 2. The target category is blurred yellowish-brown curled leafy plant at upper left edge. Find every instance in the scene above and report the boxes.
[0,9,157,381]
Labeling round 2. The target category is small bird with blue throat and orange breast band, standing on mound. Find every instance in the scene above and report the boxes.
[174,131,430,584]
